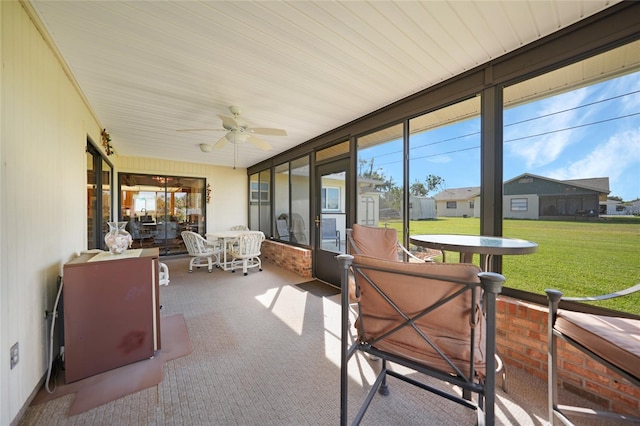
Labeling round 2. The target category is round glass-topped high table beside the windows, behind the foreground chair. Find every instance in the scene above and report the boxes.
[409,234,538,271]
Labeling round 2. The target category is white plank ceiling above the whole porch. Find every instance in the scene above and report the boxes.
[26,0,616,167]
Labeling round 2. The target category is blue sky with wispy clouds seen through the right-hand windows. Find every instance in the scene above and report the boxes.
[360,72,640,201]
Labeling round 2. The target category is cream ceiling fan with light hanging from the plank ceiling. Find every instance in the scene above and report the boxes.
[177,106,287,152]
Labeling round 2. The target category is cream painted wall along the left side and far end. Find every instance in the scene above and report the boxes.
[0,1,248,426]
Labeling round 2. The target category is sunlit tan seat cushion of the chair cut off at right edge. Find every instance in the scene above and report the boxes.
[555,310,640,378]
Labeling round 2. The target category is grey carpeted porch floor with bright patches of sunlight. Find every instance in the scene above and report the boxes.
[18,258,632,426]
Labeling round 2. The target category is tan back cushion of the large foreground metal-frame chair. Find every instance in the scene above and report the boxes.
[354,255,486,375]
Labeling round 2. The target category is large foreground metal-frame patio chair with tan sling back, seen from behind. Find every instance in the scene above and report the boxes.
[337,254,504,425]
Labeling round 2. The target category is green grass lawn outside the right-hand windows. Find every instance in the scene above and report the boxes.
[388,217,640,314]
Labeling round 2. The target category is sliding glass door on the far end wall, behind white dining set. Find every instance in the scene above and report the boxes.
[118,173,206,254]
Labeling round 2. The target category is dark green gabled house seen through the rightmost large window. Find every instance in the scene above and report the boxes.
[503,173,610,219]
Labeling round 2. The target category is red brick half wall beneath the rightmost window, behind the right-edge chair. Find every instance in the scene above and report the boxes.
[497,296,640,415]
